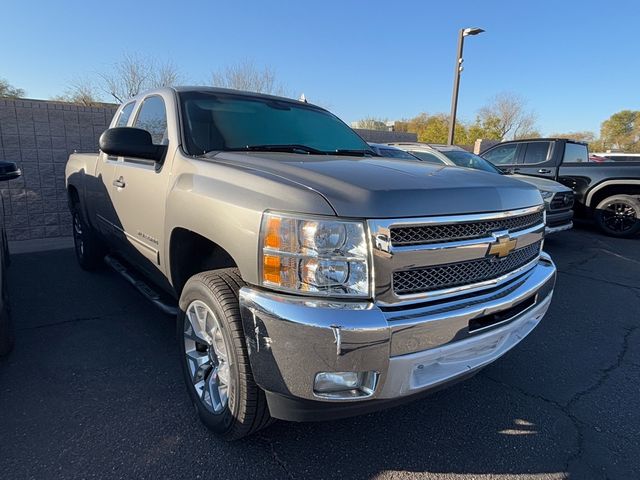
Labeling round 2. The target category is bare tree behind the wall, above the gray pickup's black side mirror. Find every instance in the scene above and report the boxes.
[99,53,181,103]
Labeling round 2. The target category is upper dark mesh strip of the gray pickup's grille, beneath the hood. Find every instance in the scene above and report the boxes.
[390,212,543,246]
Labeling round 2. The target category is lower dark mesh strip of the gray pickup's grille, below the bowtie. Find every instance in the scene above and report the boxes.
[393,242,541,295]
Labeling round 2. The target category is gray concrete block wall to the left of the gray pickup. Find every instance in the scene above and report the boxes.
[0,99,116,241]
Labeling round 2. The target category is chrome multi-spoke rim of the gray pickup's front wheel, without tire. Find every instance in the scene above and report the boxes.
[184,300,231,413]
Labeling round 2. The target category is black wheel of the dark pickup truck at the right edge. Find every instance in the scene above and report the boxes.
[594,195,640,238]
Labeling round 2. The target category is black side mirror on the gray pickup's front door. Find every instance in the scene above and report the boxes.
[100,127,167,163]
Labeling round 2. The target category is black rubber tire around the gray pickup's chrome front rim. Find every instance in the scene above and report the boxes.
[177,268,271,441]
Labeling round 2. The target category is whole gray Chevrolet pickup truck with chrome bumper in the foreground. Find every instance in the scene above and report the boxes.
[66,87,556,439]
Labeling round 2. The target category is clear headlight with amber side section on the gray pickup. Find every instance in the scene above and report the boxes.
[259,212,370,297]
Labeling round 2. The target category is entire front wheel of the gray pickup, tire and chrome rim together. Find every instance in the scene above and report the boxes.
[177,268,271,440]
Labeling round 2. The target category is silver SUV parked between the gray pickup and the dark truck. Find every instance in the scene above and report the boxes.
[384,142,574,234]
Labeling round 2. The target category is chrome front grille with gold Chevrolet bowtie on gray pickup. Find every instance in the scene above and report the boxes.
[368,205,545,306]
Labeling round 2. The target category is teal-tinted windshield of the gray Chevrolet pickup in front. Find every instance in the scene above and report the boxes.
[179,92,373,155]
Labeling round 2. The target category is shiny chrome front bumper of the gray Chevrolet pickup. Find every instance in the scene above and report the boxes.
[240,254,556,412]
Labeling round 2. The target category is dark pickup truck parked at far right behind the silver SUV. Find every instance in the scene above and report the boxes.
[481,138,640,238]
